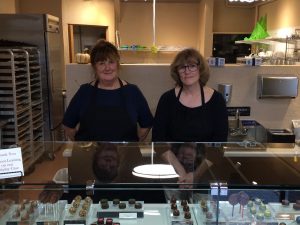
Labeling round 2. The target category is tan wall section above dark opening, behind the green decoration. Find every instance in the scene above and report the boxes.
[213,0,255,33]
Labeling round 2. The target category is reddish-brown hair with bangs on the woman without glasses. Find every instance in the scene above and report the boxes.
[91,39,120,66]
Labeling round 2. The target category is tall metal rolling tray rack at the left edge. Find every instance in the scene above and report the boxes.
[0,47,44,171]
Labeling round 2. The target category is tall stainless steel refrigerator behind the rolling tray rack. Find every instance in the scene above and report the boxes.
[0,14,64,141]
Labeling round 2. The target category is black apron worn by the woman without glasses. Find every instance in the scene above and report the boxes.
[75,79,139,142]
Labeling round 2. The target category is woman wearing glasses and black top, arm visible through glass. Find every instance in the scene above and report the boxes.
[152,48,228,186]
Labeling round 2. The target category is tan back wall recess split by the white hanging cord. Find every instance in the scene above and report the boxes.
[120,2,199,47]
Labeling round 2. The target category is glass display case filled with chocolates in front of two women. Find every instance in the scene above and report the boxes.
[0,142,300,225]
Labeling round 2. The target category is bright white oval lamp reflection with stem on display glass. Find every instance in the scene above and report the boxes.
[132,142,179,179]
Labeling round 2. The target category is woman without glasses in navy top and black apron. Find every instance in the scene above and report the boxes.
[63,40,153,142]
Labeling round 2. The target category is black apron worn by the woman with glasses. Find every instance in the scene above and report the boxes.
[170,85,213,142]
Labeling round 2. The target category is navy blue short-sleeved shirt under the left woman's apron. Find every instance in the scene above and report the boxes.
[63,83,153,128]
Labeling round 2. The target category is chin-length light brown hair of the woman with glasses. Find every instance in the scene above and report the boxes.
[171,48,209,87]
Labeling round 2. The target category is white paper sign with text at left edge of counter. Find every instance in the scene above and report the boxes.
[0,148,24,179]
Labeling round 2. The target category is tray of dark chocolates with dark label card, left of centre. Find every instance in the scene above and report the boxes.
[96,198,144,219]
